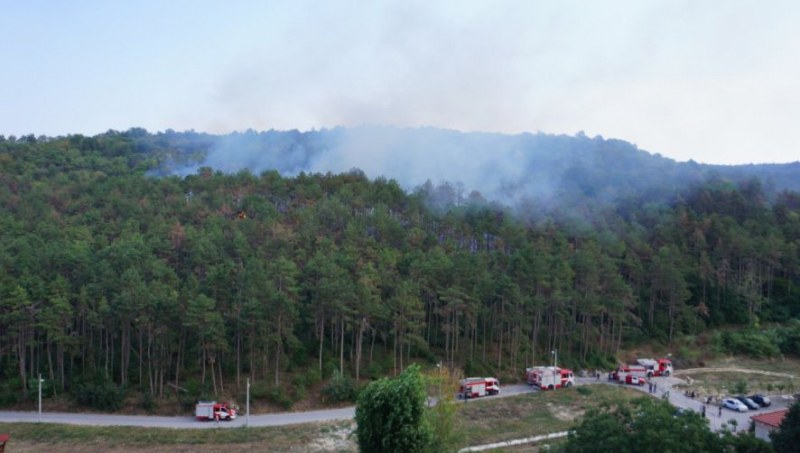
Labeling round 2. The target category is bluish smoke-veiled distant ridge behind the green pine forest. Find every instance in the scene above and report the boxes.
[139,127,800,210]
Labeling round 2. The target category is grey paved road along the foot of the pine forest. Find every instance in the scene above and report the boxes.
[0,377,787,430]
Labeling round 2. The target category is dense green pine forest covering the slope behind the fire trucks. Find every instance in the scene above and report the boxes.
[0,129,800,401]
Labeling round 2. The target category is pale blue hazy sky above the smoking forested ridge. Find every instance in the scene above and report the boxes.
[0,0,800,164]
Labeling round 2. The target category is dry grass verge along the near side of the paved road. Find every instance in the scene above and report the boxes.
[0,385,641,453]
